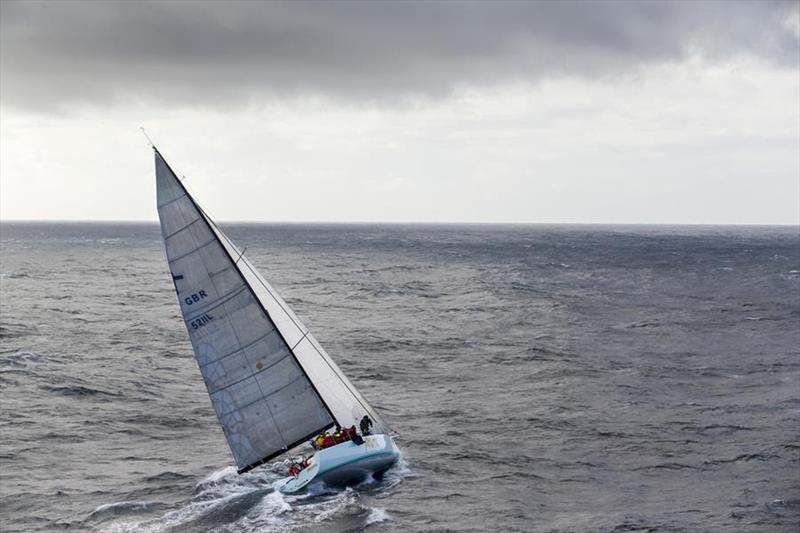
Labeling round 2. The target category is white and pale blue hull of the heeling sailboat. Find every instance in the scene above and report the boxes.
[276,435,400,493]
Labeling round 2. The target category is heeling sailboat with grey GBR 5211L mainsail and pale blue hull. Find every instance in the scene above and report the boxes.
[153,146,399,493]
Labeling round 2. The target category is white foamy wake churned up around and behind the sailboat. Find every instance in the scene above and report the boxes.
[99,457,411,533]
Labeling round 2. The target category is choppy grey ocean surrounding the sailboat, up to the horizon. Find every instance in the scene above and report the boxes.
[0,223,800,532]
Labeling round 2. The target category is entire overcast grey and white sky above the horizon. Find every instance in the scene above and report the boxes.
[0,0,800,224]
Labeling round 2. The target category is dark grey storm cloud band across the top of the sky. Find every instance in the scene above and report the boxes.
[0,1,798,108]
